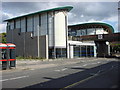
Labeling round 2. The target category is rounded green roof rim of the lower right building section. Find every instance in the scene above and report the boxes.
[69,22,114,33]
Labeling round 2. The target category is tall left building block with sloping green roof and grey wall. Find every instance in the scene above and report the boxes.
[5,6,73,58]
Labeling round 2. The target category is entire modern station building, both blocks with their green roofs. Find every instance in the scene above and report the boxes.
[5,6,114,59]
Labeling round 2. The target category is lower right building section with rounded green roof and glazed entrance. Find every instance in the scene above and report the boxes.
[68,22,114,57]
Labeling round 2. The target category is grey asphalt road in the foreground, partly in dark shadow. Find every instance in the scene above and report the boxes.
[0,59,120,89]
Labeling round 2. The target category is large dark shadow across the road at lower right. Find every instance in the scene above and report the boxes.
[18,61,120,89]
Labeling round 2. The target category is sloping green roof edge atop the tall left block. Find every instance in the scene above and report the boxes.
[4,6,73,21]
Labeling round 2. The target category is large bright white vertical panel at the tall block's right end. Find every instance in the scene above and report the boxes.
[54,12,66,47]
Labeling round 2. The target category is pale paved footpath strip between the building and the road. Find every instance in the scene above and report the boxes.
[0,58,118,72]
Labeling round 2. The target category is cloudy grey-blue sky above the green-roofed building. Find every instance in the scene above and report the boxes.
[0,1,120,33]
